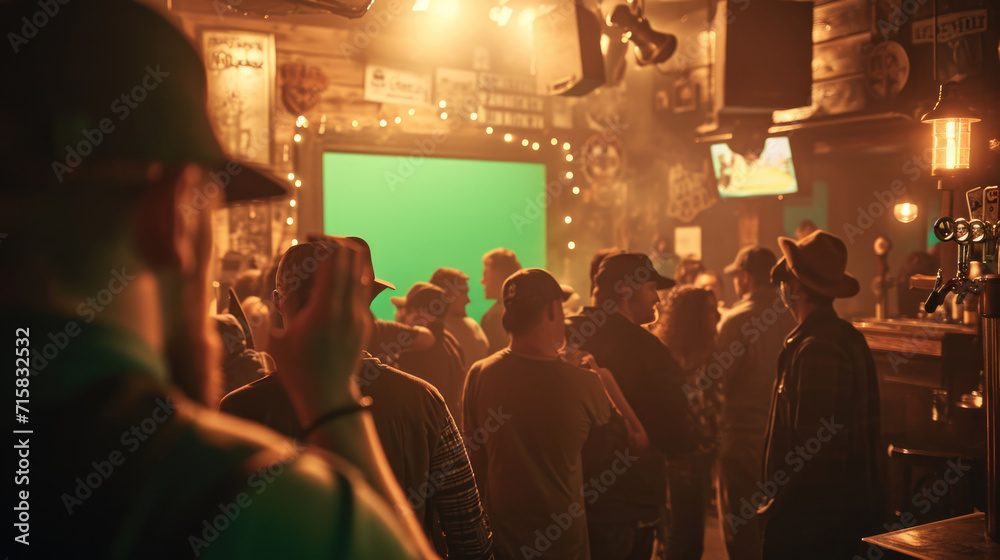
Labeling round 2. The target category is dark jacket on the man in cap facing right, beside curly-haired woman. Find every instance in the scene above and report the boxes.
[566,307,698,522]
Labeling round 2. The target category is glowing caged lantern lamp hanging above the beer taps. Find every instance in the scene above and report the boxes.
[920,83,981,175]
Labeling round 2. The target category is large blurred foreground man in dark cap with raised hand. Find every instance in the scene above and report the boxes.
[0,0,433,558]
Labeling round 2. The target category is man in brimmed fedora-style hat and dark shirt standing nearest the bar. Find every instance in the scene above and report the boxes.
[752,230,884,559]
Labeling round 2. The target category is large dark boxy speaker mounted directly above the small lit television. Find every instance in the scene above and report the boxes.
[716,0,813,110]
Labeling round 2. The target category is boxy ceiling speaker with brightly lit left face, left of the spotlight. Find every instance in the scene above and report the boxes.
[532,0,604,96]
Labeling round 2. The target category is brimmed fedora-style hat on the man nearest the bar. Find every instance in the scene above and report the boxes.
[771,229,861,298]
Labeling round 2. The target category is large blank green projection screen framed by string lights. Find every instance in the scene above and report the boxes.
[323,152,545,321]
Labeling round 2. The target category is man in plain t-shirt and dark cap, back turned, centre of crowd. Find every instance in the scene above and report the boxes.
[464,268,623,560]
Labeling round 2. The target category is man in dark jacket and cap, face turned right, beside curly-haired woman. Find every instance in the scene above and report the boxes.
[566,252,697,560]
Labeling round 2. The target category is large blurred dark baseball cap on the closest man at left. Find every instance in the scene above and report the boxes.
[0,0,287,202]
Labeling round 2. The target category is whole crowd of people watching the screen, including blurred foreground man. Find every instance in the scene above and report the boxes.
[0,0,884,560]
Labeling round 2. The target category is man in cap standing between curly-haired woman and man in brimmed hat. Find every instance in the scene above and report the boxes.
[716,247,795,560]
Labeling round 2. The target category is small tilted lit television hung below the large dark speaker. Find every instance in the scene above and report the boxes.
[709,136,799,198]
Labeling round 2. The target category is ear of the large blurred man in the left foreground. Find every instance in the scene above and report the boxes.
[133,164,211,270]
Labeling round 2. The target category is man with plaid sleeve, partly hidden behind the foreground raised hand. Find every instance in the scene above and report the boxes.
[220,241,492,560]
